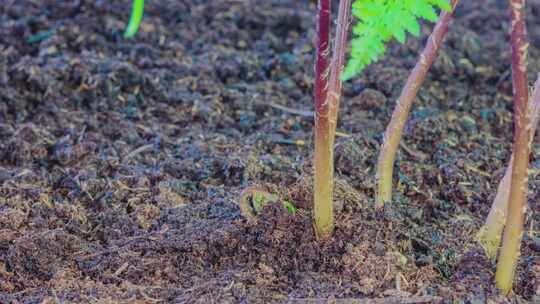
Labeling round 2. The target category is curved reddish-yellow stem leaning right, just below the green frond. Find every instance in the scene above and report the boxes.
[376,0,459,208]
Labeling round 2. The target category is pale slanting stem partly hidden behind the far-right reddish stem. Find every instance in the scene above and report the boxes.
[478,74,540,260]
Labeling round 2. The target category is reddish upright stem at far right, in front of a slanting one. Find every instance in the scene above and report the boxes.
[495,0,532,294]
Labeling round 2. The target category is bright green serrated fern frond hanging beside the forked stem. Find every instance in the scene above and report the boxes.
[342,0,452,80]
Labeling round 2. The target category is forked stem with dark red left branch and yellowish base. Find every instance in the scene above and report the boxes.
[314,0,351,239]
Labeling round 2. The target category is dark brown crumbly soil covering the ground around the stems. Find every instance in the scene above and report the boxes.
[0,0,540,303]
